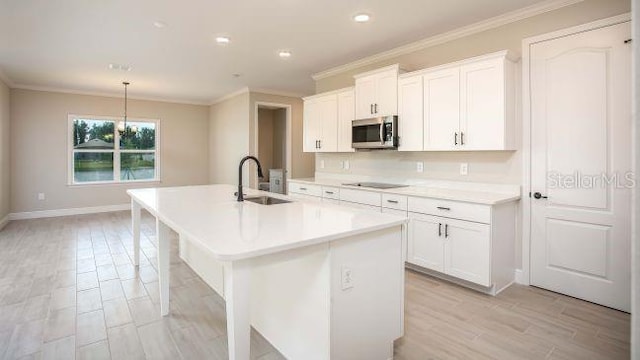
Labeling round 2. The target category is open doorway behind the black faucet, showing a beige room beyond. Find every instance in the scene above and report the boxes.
[255,103,291,194]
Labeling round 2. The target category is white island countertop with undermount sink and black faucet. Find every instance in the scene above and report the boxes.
[127,185,407,261]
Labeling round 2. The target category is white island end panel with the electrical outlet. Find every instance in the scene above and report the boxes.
[330,225,404,360]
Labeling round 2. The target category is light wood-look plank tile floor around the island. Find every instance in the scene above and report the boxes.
[0,212,630,360]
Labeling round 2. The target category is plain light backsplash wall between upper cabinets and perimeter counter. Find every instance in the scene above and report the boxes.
[316,150,522,184]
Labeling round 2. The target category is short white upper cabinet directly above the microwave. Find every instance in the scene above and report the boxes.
[355,64,399,119]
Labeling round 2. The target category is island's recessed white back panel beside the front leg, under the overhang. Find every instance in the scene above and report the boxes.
[251,243,331,360]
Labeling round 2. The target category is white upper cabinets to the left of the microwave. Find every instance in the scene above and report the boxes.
[303,88,355,152]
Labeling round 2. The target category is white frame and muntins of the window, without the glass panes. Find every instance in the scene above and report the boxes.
[67,114,161,187]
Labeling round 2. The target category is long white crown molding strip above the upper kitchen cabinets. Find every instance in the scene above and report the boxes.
[311,0,584,81]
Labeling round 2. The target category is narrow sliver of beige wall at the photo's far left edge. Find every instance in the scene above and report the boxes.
[0,80,11,225]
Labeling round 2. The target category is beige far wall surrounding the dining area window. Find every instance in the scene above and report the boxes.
[11,89,209,213]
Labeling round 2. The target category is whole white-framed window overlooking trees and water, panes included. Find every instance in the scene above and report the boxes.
[69,115,160,184]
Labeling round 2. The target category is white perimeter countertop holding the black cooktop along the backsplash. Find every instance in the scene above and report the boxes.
[289,178,520,205]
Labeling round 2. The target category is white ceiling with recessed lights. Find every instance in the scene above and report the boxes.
[0,0,543,104]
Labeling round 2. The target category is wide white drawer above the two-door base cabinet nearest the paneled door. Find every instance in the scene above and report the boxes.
[408,197,491,224]
